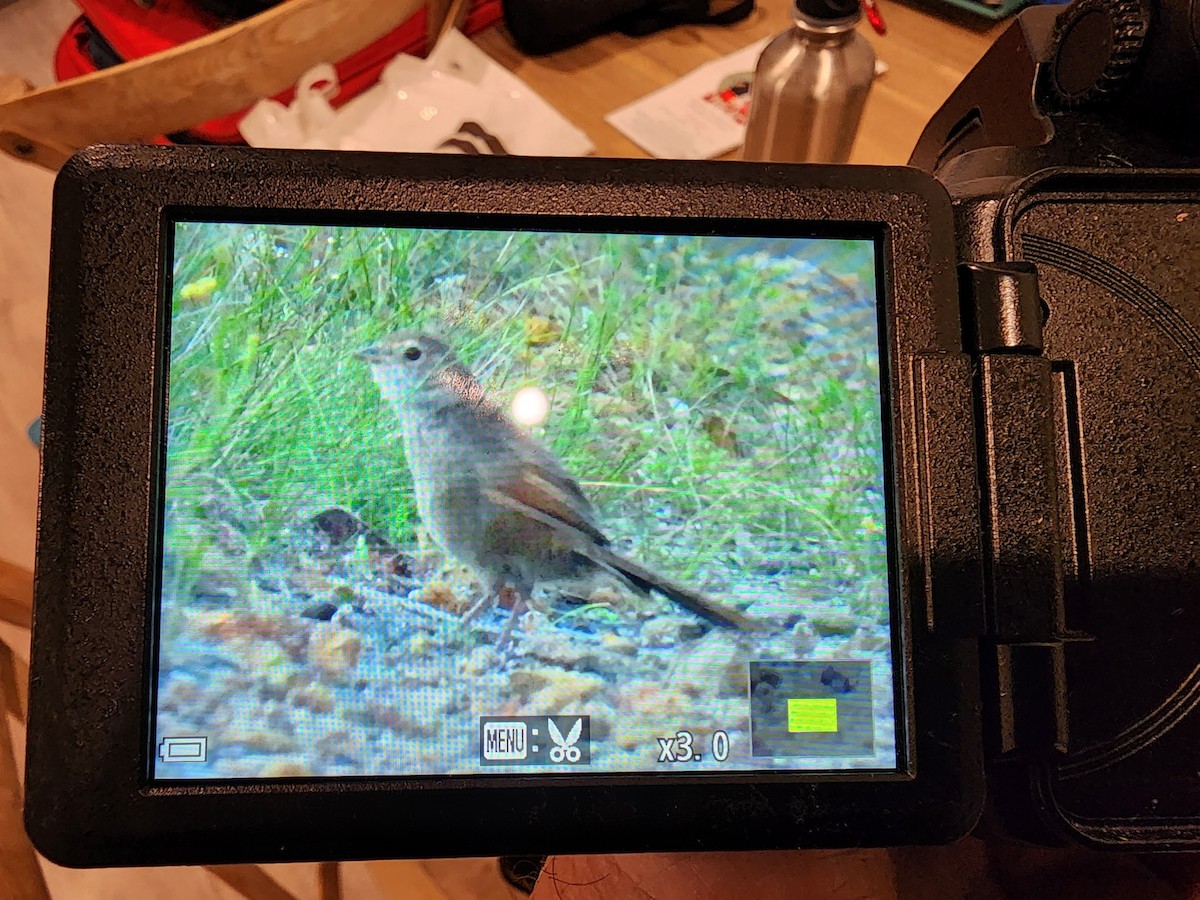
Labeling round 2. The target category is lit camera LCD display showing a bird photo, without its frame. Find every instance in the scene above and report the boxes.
[149,220,902,780]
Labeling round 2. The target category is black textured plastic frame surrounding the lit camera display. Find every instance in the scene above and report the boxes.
[28,148,983,865]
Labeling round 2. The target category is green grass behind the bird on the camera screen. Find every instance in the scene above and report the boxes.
[167,224,884,619]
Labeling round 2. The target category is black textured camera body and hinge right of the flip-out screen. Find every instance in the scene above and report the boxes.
[911,0,1200,850]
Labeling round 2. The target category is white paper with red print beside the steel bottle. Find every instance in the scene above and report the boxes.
[605,37,888,160]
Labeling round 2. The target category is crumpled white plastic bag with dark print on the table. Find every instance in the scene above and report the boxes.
[240,31,593,156]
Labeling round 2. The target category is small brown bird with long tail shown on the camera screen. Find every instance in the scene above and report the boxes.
[358,331,748,628]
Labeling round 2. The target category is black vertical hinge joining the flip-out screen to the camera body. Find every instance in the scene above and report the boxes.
[959,263,1072,758]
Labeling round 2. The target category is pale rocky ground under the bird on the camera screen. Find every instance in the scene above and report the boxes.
[156,509,895,779]
